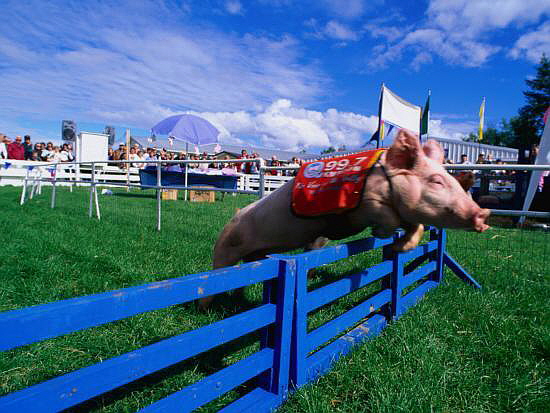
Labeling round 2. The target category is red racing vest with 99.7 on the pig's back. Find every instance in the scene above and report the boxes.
[291,149,386,217]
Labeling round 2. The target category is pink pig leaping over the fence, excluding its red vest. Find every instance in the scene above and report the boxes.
[205,129,490,305]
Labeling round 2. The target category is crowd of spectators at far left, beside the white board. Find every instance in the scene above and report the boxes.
[0,134,74,163]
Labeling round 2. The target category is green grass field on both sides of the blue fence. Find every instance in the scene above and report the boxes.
[0,187,550,413]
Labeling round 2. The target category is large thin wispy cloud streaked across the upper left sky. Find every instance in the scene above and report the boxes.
[0,2,329,128]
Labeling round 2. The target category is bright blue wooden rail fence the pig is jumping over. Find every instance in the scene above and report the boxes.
[0,229,479,413]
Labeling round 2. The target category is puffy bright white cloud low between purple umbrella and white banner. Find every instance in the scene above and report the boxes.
[188,99,378,150]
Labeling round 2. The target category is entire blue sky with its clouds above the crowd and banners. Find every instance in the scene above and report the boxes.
[0,0,550,151]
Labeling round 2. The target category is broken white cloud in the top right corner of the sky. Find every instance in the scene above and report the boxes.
[366,0,550,70]
